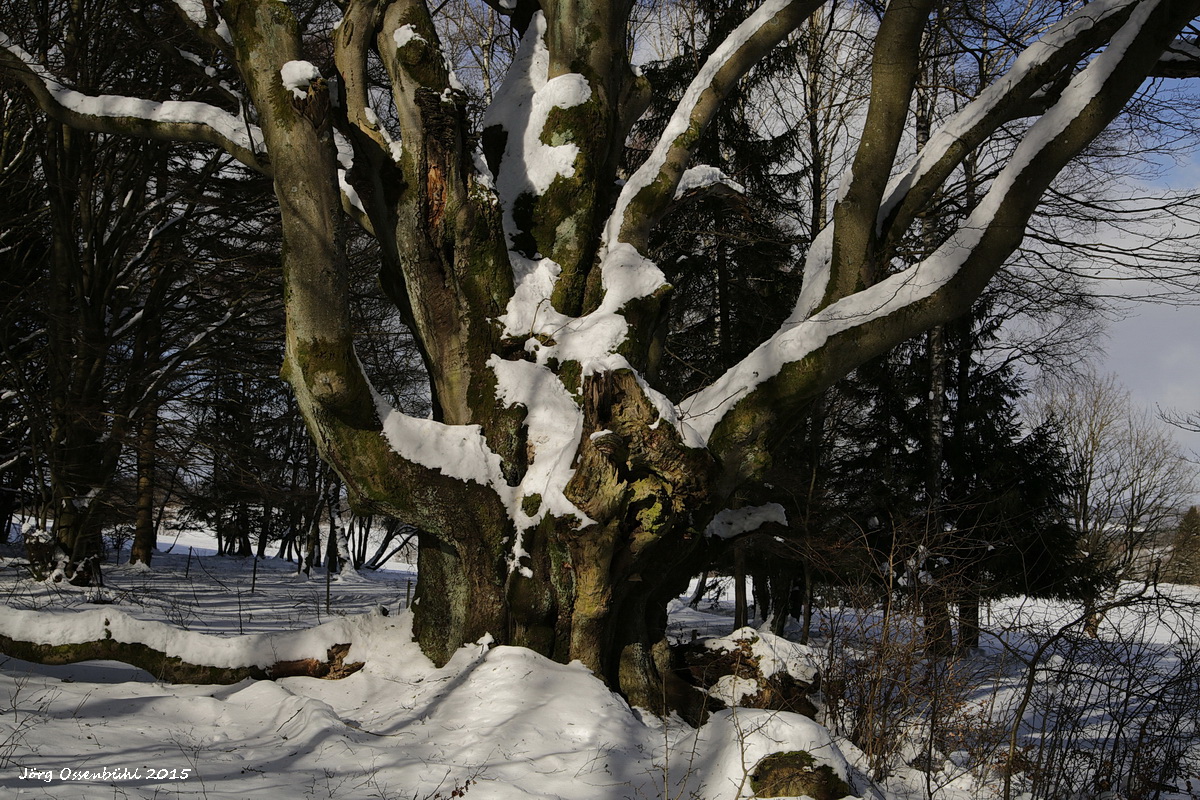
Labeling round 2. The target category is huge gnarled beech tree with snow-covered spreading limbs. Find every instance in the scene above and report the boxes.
[0,0,1200,708]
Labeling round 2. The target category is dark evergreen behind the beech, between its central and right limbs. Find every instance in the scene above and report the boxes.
[626,0,806,393]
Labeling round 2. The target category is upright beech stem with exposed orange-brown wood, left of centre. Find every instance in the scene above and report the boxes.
[377,0,512,431]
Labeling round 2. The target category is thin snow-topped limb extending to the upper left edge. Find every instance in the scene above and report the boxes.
[0,32,269,173]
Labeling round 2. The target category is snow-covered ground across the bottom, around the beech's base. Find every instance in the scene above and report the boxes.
[0,532,1200,800]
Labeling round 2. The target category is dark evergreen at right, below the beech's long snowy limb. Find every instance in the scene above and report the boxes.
[832,293,1102,646]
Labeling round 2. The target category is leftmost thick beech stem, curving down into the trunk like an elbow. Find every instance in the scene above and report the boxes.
[211,0,510,540]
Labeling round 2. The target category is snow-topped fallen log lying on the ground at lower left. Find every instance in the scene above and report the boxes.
[0,608,362,684]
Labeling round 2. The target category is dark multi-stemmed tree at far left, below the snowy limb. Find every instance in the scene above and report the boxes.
[6,101,232,581]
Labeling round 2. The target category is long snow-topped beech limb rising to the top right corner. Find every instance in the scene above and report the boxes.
[683,0,1200,486]
